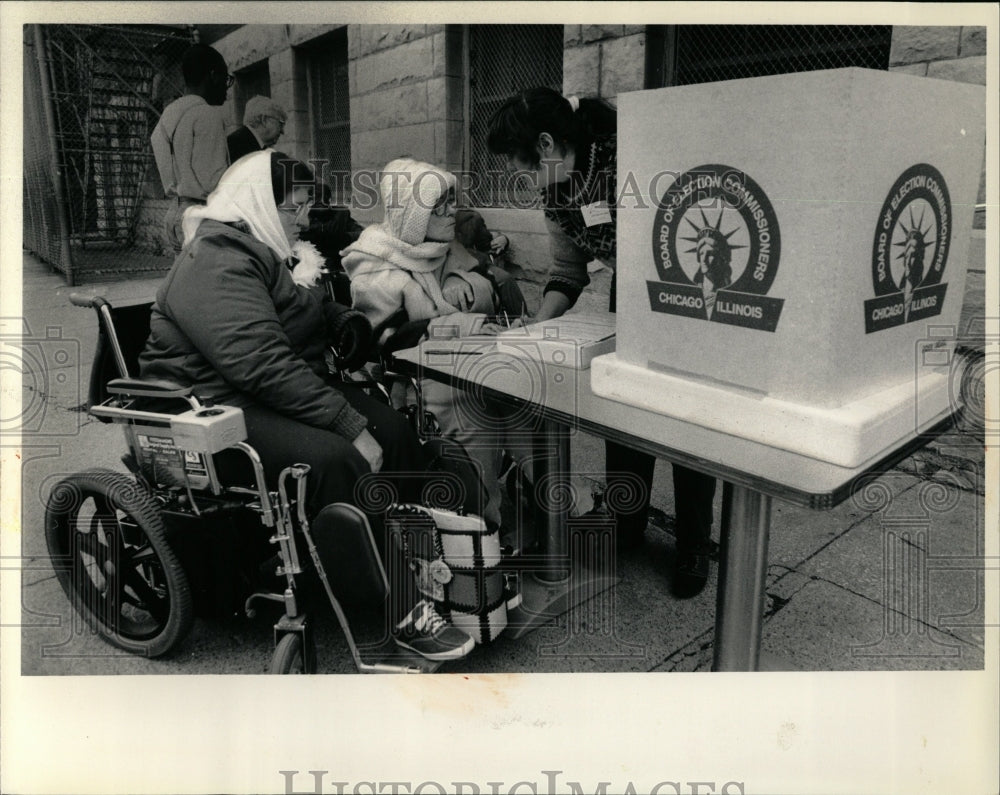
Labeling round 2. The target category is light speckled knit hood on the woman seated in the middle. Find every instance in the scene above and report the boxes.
[379,157,455,244]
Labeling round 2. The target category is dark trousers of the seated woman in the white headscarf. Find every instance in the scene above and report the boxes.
[216,387,430,623]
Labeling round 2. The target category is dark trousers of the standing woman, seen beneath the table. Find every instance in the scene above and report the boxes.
[604,274,715,553]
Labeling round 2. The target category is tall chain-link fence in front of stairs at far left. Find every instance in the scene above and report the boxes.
[24,25,193,284]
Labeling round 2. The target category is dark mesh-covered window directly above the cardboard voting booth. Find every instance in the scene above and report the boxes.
[664,25,892,86]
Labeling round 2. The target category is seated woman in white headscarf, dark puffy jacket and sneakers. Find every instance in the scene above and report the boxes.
[140,151,473,660]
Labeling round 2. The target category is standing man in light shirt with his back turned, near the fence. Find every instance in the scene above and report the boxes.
[150,44,233,253]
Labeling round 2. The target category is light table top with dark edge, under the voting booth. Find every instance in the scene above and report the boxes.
[393,337,951,510]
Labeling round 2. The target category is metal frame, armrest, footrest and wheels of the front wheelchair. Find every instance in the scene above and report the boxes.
[45,294,430,674]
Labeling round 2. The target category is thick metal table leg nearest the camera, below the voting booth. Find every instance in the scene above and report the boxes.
[712,483,771,671]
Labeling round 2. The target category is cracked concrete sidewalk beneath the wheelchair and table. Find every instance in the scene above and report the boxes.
[13,255,984,674]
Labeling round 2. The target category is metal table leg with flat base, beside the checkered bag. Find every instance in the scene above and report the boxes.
[507,421,618,638]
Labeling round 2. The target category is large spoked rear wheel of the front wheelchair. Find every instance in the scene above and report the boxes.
[45,470,194,657]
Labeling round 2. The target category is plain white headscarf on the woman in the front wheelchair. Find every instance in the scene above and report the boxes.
[182,149,292,260]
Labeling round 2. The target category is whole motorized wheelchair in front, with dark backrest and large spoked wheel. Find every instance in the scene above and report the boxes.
[45,294,482,674]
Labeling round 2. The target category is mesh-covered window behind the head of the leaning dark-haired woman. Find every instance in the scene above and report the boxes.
[468,25,563,207]
